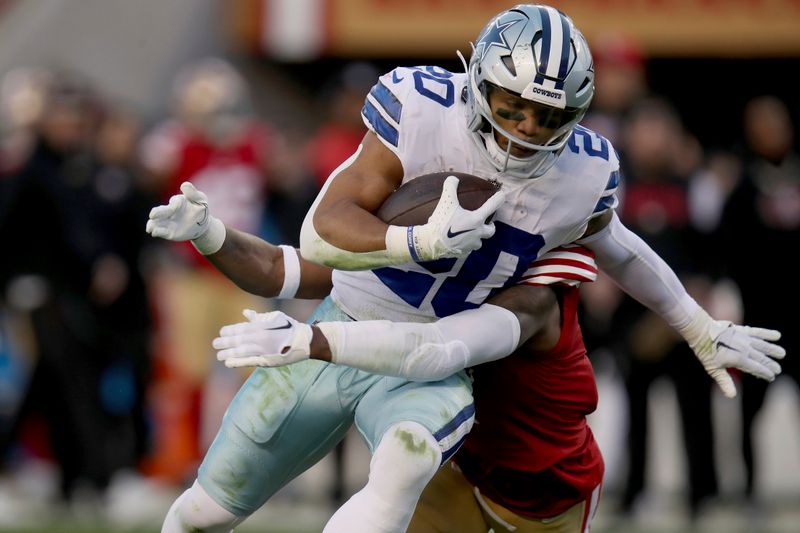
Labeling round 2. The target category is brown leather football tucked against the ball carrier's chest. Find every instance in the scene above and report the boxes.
[376,172,500,226]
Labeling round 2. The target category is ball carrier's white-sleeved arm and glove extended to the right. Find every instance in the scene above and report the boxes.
[579,211,786,398]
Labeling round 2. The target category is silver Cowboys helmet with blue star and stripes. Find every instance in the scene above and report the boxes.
[467,4,594,178]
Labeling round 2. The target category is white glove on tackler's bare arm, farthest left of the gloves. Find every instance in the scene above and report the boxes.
[145,181,225,255]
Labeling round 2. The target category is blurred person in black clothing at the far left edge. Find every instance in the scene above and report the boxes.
[0,71,99,498]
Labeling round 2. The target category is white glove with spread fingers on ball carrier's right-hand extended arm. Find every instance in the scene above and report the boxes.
[683,309,786,398]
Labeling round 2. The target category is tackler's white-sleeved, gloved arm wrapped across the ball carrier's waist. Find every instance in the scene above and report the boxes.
[213,285,560,381]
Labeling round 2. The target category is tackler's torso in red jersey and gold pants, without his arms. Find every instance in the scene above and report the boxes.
[408,279,604,533]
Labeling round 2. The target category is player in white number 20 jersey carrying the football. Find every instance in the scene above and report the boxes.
[148,5,779,532]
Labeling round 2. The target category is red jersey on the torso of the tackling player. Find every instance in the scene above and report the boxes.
[455,286,604,518]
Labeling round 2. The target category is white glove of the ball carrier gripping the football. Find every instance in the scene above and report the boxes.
[386,176,505,261]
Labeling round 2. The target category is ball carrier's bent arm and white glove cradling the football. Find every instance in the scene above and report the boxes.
[300,132,504,270]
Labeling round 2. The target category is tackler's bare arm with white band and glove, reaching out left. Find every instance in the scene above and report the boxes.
[145,182,331,298]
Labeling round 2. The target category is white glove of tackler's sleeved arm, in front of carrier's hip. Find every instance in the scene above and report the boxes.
[212,309,312,368]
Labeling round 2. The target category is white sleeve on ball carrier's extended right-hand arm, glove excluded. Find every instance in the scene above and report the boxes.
[580,215,699,333]
